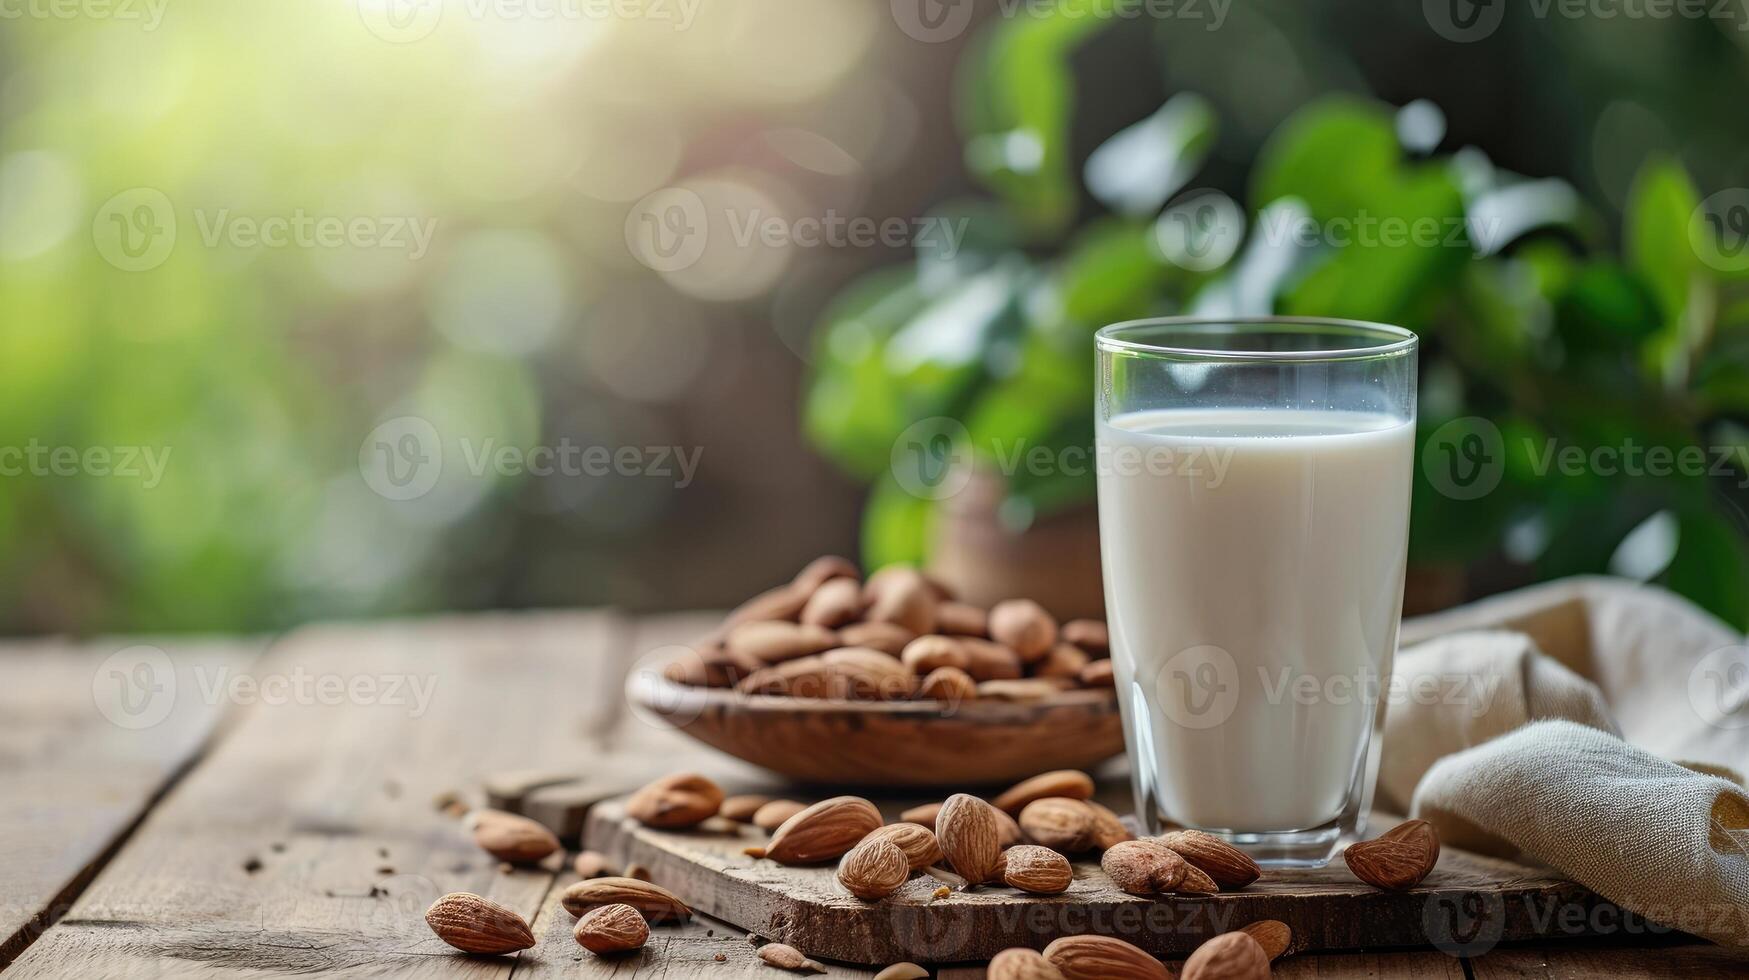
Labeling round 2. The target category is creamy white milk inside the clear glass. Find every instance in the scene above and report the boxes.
[1098,410,1415,833]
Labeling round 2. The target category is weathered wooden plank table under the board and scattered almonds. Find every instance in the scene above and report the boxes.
[0,613,1749,980]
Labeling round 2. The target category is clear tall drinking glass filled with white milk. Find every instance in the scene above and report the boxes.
[1095,317,1417,866]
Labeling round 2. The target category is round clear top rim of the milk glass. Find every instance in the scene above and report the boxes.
[1093,317,1420,362]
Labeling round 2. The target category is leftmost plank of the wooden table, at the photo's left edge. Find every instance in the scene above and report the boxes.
[0,637,264,966]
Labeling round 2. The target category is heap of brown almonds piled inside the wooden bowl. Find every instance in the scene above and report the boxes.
[665,555,1112,704]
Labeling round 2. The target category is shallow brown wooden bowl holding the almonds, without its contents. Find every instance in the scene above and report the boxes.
[626,670,1123,788]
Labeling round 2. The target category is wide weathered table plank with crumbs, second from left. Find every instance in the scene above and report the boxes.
[7,614,626,980]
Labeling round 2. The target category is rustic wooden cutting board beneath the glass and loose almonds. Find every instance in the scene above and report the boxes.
[584,800,1621,964]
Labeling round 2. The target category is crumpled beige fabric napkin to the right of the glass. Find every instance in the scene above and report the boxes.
[1378,578,1749,945]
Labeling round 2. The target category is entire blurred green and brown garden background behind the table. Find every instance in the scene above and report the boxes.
[0,0,1749,634]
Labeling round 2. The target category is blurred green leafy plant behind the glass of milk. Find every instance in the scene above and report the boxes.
[805,12,1749,627]
